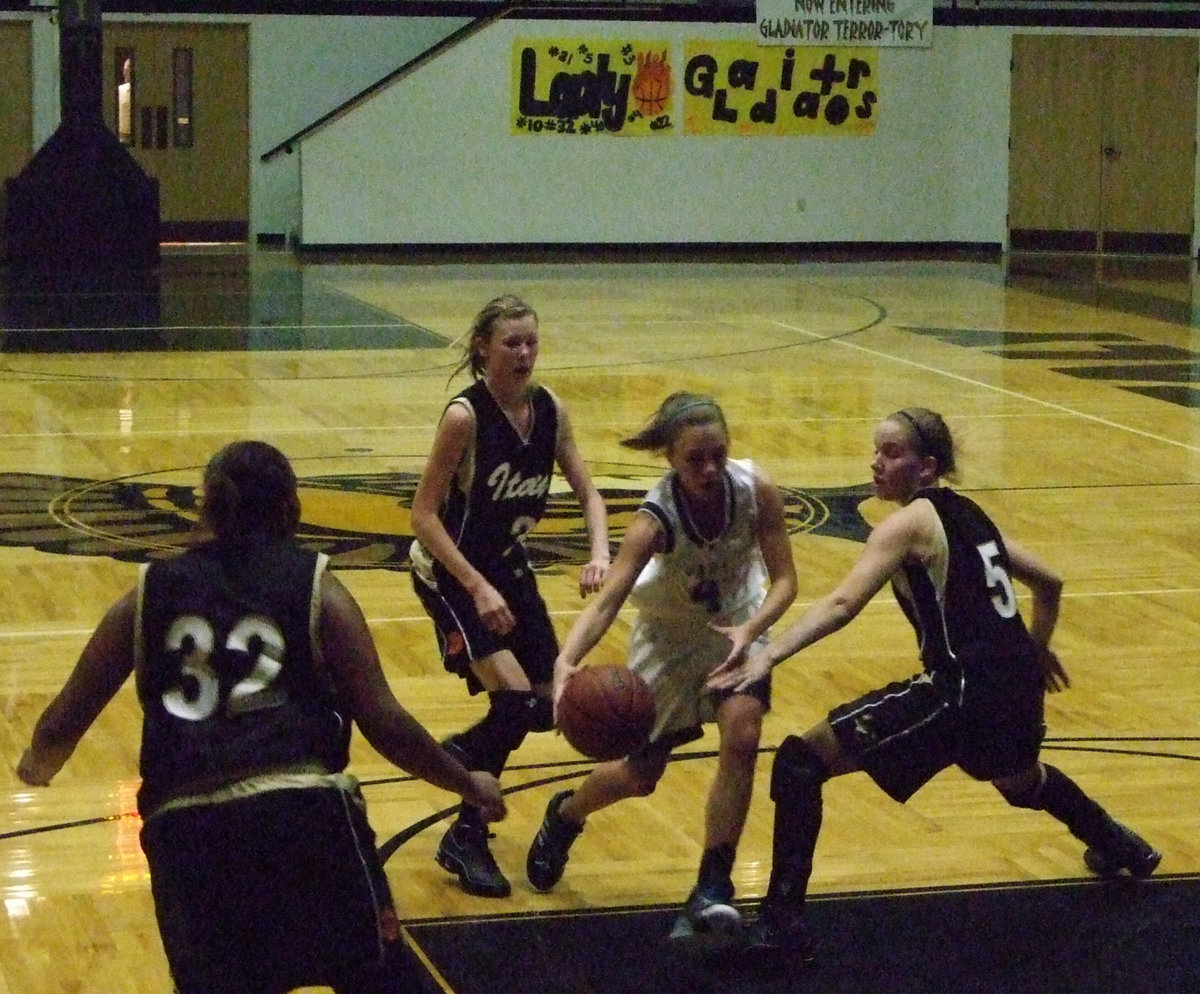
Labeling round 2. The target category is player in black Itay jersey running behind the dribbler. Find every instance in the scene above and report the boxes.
[412,295,610,897]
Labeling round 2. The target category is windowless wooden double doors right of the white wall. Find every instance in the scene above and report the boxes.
[1008,35,1198,255]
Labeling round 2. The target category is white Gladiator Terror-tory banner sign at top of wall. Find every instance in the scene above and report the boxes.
[757,0,934,48]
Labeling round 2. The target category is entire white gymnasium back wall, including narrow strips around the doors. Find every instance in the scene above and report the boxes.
[8,13,1196,246]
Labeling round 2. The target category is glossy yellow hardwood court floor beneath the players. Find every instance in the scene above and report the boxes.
[0,250,1200,994]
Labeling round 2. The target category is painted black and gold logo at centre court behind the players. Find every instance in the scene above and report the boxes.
[0,466,871,573]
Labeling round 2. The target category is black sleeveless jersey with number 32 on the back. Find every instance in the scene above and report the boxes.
[134,537,350,814]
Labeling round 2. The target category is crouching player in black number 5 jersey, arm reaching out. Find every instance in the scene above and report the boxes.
[710,407,1162,959]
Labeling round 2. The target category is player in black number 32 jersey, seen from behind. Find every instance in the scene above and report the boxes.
[17,442,504,994]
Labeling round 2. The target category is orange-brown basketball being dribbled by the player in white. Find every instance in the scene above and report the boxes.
[558,665,655,760]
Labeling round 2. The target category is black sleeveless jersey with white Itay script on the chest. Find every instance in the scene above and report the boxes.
[440,379,558,583]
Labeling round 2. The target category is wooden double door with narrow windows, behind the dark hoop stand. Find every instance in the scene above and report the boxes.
[104,23,250,241]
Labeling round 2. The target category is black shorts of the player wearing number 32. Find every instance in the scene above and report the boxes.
[142,786,415,994]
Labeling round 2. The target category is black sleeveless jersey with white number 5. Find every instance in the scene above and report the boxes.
[893,487,1042,702]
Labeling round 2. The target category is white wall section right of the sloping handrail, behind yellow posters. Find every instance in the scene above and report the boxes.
[300,20,1012,246]
